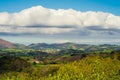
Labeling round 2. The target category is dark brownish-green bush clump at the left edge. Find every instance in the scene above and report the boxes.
[0,56,30,73]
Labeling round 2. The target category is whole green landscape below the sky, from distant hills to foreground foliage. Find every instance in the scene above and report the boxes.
[0,38,120,80]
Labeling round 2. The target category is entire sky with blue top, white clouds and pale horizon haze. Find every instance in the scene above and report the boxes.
[0,0,120,44]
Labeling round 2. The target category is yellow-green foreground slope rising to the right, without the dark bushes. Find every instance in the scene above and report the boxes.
[0,53,120,80]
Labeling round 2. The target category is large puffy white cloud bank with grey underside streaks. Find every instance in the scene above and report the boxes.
[0,6,120,36]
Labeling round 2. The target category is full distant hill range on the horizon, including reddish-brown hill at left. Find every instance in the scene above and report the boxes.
[0,39,120,52]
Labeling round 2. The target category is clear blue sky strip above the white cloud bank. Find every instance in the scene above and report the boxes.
[0,0,120,15]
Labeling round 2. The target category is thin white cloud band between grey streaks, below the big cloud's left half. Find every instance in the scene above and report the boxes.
[0,26,74,34]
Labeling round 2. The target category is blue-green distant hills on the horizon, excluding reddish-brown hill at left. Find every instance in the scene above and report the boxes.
[28,42,120,51]
